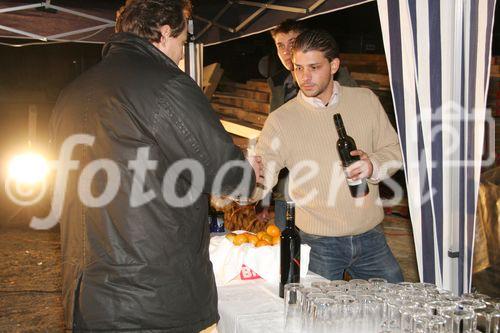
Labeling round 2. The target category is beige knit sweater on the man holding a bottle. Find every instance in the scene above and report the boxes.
[254,87,401,236]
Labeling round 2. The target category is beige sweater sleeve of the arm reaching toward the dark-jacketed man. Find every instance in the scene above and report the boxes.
[252,114,286,201]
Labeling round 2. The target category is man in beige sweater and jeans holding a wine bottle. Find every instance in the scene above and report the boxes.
[255,30,403,282]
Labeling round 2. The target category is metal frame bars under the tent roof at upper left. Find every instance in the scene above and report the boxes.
[0,0,115,42]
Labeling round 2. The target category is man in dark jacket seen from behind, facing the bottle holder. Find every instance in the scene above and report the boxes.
[51,0,260,332]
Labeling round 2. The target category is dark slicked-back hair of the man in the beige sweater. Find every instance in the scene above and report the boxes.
[292,29,340,61]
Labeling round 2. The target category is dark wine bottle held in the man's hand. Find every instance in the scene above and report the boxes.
[333,113,370,198]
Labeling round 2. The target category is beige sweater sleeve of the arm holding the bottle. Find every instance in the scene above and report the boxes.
[368,93,402,182]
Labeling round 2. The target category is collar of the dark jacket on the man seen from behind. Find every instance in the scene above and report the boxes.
[102,32,177,67]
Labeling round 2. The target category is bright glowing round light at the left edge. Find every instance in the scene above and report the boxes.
[8,152,49,184]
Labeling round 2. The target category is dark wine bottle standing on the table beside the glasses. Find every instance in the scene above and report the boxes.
[279,202,300,298]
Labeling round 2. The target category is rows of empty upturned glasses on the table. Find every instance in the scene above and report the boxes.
[284,278,500,333]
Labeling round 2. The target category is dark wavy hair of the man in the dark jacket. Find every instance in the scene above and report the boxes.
[115,0,191,43]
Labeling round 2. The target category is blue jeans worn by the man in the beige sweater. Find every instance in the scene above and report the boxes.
[300,225,403,283]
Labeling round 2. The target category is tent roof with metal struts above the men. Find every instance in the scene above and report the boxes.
[0,0,373,45]
